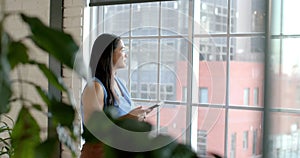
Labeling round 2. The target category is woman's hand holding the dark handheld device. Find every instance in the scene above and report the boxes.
[121,106,152,121]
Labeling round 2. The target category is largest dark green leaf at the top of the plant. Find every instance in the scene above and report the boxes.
[21,14,79,68]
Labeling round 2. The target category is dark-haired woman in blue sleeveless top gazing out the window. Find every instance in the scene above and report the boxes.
[81,34,149,158]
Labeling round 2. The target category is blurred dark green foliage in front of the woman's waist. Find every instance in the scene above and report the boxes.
[85,112,197,158]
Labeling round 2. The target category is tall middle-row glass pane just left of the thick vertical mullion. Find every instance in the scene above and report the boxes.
[160,38,189,101]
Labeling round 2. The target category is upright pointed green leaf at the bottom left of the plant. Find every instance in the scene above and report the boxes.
[12,106,40,158]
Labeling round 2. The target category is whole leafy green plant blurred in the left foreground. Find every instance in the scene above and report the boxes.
[0,13,80,158]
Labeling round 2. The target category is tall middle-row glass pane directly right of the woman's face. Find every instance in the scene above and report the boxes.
[130,39,158,100]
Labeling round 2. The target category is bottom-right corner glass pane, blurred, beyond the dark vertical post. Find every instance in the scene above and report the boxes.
[268,112,300,158]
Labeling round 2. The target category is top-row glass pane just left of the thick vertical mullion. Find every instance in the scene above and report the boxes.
[161,0,189,35]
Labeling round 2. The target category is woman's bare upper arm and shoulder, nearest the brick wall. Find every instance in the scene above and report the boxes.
[82,82,104,123]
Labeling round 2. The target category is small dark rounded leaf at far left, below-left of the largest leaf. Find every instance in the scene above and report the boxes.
[7,42,29,69]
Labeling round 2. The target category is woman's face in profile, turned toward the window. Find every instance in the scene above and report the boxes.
[113,40,127,69]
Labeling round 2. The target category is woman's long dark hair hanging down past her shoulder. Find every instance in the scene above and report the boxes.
[90,34,121,106]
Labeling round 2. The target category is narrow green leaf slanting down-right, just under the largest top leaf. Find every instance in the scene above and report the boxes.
[30,61,67,92]
